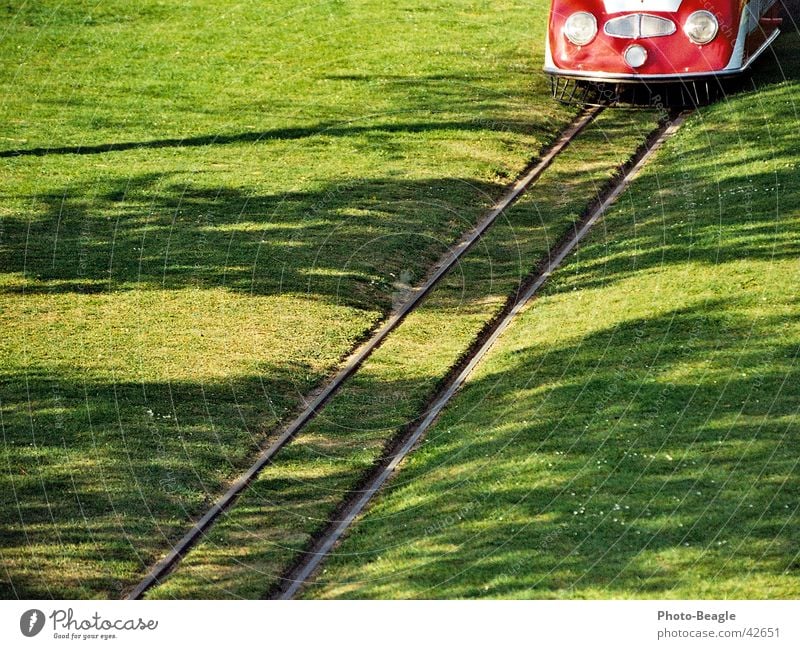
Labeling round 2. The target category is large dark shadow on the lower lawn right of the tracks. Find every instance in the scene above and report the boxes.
[318,299,800,598]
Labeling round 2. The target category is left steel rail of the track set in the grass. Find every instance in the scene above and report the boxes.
[126,107,603,599]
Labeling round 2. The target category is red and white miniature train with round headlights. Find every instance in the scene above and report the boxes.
[544,0,781,102]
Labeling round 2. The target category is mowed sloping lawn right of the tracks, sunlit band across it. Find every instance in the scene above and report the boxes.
[305,37,800,599]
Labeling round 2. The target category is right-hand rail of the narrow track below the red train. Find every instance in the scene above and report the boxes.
[275,110,692,599]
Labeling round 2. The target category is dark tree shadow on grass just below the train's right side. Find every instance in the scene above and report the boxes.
[544,64,800,291]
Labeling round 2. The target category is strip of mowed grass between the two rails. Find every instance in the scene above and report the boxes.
[148,112,657,598]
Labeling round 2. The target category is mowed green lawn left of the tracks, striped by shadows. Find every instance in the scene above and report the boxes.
[0,0,571,598]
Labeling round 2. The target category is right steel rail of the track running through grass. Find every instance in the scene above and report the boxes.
[276,113,688,599]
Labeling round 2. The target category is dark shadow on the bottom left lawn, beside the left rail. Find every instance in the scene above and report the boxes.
[0,366,328,598]
